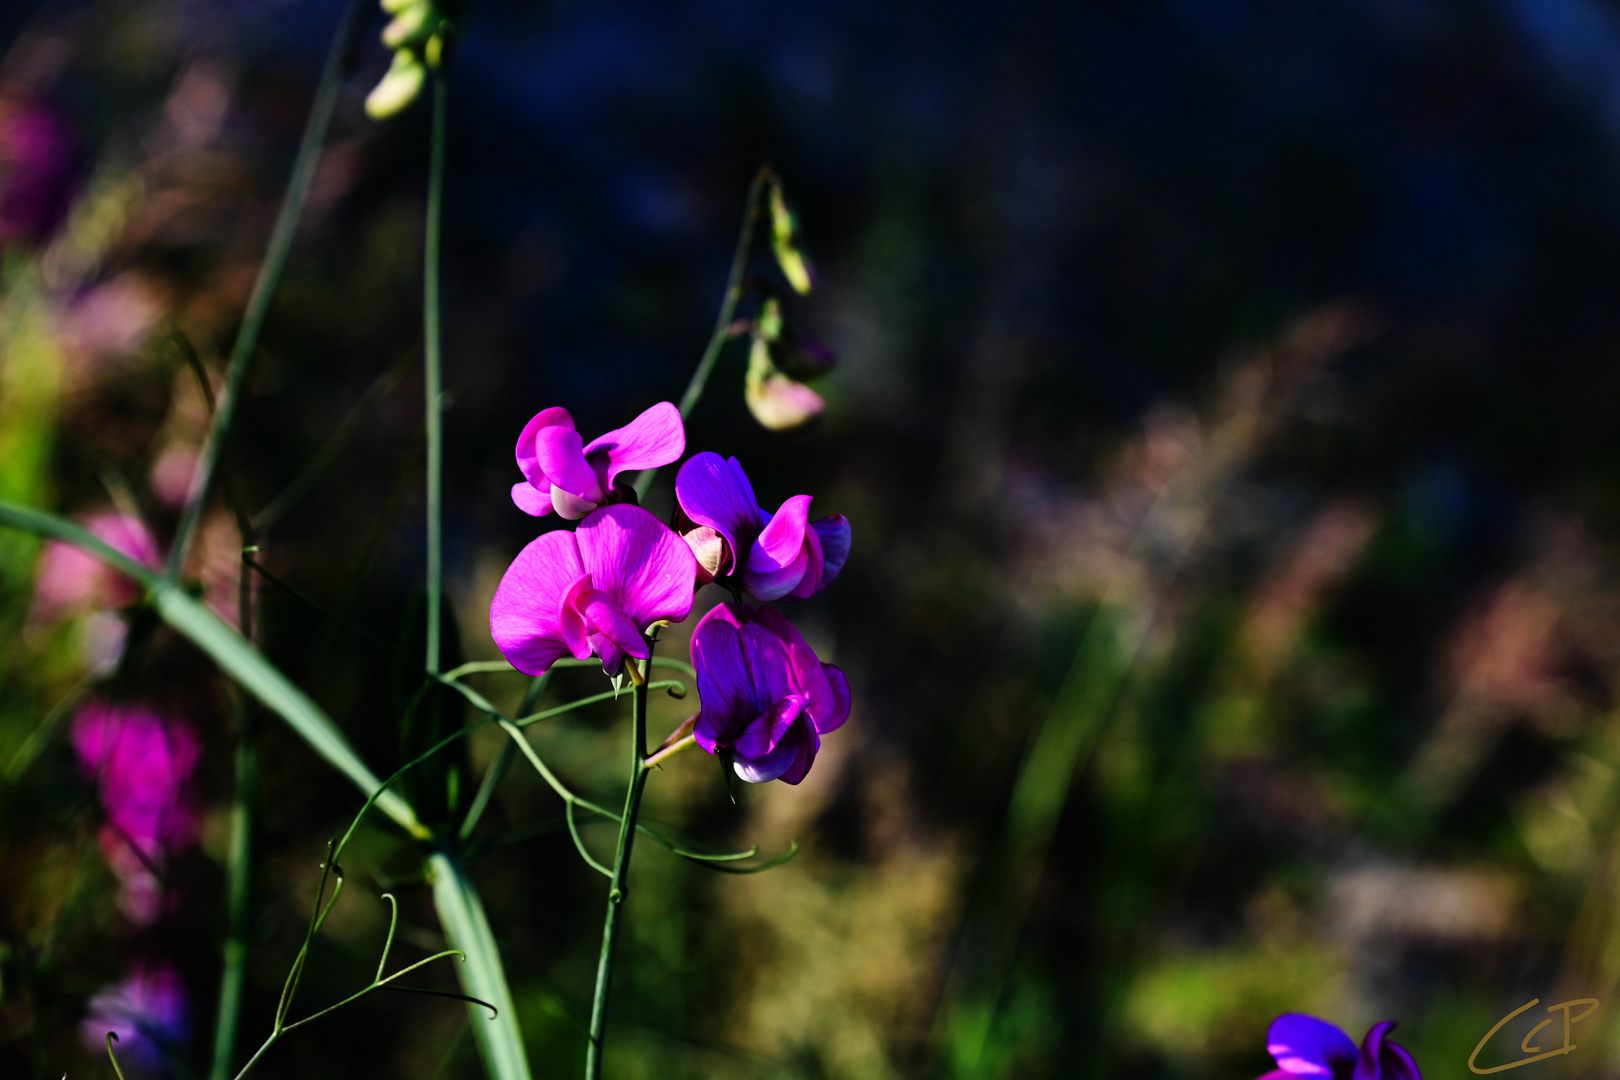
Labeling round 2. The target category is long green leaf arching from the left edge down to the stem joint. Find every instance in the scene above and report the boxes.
[0,499,428,839]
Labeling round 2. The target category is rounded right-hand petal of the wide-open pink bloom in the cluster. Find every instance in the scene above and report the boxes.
[573,504,698,630]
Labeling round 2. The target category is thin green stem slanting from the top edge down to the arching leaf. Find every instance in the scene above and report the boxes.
[164,0,371,581]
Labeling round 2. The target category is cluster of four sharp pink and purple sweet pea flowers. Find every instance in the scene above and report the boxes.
[489,402,851,784]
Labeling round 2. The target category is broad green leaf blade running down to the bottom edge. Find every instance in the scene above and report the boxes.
[428,852,530,1080]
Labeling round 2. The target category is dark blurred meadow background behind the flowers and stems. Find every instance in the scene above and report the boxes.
[0,0,1620,1080]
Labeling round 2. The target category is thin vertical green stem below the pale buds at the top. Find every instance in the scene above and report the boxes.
[421,71,450,675]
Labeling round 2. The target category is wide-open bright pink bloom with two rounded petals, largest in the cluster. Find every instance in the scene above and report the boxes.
[489,504,697,675]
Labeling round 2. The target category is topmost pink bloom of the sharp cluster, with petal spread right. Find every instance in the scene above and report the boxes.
[512,402,687,521]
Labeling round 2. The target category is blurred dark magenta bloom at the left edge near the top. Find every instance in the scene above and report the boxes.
[0,97,73,244]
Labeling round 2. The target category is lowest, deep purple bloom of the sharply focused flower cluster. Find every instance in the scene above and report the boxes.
[692,604,849,784]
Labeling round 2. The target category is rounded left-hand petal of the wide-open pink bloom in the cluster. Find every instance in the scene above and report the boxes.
[489,529,585,675]
